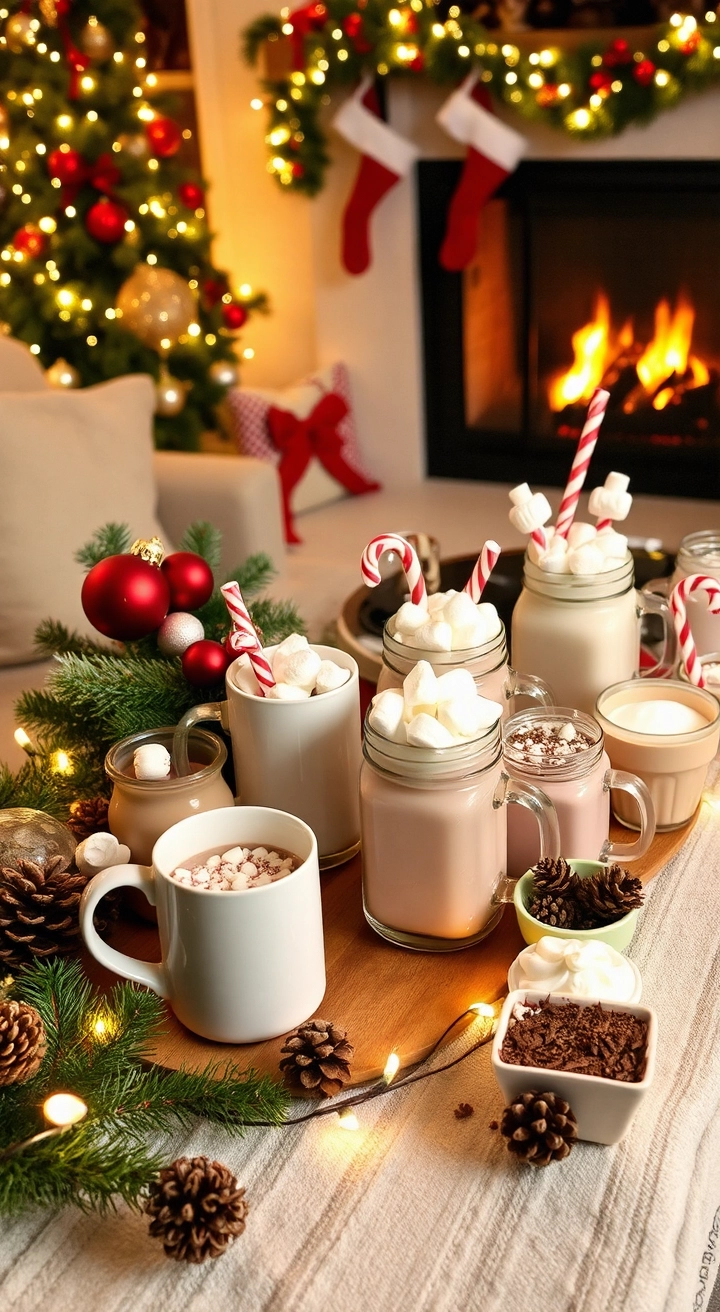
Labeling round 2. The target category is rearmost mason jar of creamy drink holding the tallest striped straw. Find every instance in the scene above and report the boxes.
[513,552,675,714]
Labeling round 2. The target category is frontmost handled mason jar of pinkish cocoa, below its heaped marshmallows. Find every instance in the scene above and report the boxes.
[361,719,560,953]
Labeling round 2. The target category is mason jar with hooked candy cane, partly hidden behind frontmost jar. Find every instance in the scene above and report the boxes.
[378,617,555,716]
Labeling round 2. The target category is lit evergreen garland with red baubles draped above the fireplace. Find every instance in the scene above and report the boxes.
[244,0,720,195]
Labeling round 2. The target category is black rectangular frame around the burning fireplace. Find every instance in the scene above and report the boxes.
[417,160,720,499]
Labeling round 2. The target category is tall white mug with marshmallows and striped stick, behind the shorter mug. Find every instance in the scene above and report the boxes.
[173,643,362,870]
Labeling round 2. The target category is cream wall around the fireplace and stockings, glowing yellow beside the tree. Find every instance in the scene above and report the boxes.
[188,0,720,485]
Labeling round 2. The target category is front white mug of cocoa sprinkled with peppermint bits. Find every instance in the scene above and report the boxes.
[80,807,325,1043]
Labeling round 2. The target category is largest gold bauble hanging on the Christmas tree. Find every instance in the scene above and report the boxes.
[117,264,195,354]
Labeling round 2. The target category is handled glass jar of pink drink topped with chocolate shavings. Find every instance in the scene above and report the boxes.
[502,706,656,879]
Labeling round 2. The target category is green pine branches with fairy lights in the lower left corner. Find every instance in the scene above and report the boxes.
[0,960,289,1216]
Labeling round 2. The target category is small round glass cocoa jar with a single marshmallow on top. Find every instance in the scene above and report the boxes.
[105,728,235,866]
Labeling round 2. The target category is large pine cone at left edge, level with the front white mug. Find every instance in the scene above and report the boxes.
[0,857,88,967]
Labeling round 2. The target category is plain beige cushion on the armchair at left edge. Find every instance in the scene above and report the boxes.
[0,374,163,665]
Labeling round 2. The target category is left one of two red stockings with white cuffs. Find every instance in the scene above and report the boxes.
[333,77,418,273]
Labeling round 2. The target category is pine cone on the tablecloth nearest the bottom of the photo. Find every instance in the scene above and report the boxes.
[144,1157,248,1262]
